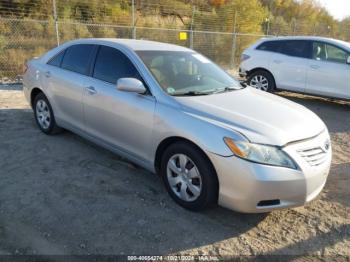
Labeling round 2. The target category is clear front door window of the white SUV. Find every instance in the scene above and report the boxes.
[313,42,349,64]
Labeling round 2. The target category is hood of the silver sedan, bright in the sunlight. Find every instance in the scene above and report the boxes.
[175,87,325,146]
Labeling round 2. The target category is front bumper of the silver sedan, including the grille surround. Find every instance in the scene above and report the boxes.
[208,132,332,213]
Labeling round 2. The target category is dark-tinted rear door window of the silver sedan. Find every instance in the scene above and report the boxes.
[61,44,95,75]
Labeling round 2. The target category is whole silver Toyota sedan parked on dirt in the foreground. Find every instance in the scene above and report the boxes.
[23,39,332,213]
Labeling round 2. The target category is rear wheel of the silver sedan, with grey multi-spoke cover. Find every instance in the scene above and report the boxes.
[33,93,63,135]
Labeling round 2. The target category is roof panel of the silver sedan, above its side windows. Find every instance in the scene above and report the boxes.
[61,38,193,52]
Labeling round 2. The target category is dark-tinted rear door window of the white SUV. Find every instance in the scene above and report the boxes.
[280,40,311,58]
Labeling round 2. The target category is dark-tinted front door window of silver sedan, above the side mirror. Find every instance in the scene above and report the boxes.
[93,46,142,84]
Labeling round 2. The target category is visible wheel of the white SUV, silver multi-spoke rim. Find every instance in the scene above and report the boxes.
[247,70,276,93]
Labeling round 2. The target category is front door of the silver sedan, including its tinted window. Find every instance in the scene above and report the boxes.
[83,46,156,161]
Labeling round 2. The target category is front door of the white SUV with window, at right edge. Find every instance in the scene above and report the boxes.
[306,42,350,99]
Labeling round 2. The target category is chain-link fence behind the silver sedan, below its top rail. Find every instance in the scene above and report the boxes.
[0,18,256,83]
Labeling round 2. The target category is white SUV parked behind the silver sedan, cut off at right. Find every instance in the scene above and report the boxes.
[239,37,350,99]
